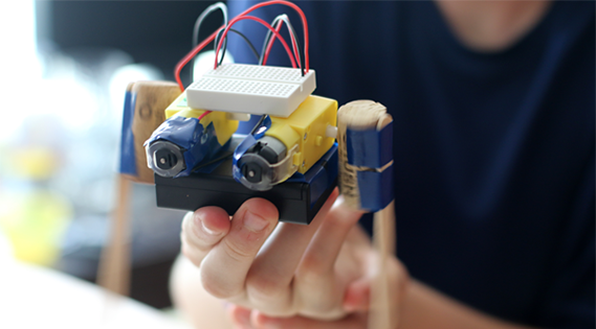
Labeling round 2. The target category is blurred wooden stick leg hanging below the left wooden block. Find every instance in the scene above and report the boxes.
[97,175,131,296]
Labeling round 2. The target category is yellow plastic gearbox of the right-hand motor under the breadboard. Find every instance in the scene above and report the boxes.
[265,95,337,174]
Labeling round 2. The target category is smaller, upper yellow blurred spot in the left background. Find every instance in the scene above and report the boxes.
[13,147,58,181]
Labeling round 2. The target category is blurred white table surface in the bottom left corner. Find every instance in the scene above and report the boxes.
[0,231,190,329]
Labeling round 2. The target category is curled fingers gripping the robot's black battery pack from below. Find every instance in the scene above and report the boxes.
[182,191,408,320]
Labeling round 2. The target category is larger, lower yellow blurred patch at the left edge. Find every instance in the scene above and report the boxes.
[0,190,72,265]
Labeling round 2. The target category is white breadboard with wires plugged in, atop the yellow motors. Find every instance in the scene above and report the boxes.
[186,64,316,118]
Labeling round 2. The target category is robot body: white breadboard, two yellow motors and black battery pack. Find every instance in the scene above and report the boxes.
[144,64,338,224]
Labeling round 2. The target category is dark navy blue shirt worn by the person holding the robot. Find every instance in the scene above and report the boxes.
[229,1,596,328]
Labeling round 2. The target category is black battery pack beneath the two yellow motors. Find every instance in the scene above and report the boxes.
[155,144,338,224]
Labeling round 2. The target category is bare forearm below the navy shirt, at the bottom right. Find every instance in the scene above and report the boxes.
[399,280,530,329]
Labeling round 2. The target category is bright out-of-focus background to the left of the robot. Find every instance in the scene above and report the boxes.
[0,0,221,308]
